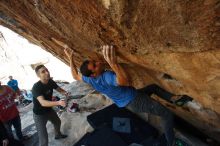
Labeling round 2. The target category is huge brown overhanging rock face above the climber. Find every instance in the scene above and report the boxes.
[0,0,220,140]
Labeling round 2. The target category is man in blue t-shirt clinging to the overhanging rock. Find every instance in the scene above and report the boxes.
[63,45,191,146]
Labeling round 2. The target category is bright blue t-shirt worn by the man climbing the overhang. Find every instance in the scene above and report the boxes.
[82,71,137,107]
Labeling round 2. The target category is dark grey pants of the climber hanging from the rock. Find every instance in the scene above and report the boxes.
[127,84,174,146]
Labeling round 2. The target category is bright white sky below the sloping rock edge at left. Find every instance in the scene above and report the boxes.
[0,25,74,89]
